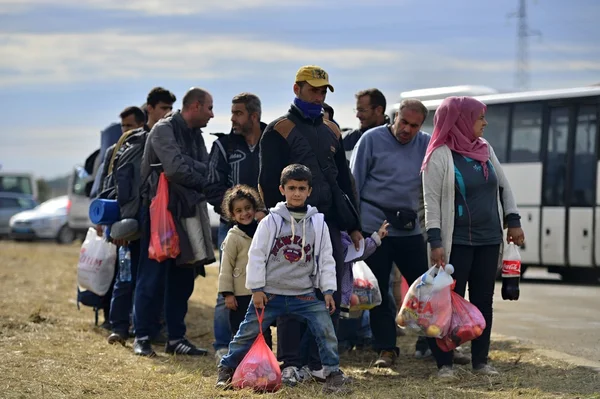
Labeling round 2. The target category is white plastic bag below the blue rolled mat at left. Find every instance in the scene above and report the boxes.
[77,227,117,296]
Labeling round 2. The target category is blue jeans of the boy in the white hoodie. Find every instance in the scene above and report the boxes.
[219,294,340,375]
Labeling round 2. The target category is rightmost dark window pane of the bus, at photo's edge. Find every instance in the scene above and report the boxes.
[571,105,598,207]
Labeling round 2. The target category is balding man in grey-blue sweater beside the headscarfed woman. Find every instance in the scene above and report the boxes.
[350,99,435,367]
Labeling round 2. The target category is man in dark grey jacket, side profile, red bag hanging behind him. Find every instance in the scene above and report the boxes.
[134,88,214,356]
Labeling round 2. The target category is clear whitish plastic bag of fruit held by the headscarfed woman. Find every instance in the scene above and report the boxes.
[396,264,454,338]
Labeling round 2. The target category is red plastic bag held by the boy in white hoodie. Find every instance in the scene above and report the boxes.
[231,308,281,392]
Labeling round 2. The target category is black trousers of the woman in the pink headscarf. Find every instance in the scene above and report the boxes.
[431,245,500,368]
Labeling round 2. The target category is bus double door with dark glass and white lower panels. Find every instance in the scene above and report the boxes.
[541,99,598,267]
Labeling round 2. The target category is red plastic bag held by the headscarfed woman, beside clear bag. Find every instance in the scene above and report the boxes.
[436,284,485,352]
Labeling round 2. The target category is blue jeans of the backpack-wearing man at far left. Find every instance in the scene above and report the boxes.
[110,240,140,337]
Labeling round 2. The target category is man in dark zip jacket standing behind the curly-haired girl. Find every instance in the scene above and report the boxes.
[205,93,267,360]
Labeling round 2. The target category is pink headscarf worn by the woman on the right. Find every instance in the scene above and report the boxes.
[421,97,490,179]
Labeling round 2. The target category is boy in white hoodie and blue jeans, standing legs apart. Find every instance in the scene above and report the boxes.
[217,164,351,394]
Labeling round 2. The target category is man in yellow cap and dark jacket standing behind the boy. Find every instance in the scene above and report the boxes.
[258,65,362,385]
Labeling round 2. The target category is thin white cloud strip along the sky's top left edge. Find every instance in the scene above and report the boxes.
[0,0,319,15]
